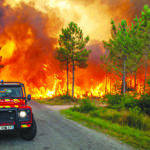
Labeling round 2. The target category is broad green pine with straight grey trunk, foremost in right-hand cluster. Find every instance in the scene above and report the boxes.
[104,20,142,93]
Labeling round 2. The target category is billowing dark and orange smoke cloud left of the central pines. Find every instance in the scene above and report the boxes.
[0,0,62,87]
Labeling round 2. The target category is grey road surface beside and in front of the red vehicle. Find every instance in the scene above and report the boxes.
[0,101,132,150]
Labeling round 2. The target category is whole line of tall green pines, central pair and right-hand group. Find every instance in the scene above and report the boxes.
[56,5,150,97]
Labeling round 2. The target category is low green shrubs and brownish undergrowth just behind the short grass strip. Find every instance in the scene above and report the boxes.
[71,98,150,130]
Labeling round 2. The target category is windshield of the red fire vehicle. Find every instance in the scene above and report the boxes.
[0,87,22,97]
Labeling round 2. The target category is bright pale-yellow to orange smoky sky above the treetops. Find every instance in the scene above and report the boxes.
[4,0,150,40]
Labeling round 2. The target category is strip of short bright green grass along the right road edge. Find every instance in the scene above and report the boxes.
[61,109,150,149]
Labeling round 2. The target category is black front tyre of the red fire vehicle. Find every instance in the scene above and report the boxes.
[20,119,37,141]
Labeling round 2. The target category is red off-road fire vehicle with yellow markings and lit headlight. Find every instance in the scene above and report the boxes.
[0,81,37,141]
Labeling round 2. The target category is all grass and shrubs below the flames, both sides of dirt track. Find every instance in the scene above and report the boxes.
[33,94,150,149]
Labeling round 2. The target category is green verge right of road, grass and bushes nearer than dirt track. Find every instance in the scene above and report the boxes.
[62,95,150,149]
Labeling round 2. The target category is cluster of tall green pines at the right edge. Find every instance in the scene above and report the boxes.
[101,5,150,93]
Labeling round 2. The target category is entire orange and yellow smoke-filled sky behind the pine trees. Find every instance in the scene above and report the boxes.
[0,0,150,95]
